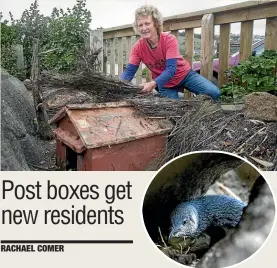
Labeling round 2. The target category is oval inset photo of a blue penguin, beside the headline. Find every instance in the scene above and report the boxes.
[142,151,275,268]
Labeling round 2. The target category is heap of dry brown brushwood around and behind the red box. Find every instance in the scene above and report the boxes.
[41,72,277,170]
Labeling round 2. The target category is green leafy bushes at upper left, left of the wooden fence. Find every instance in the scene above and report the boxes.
[1,0,91,77]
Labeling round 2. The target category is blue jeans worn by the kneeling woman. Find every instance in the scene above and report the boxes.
[158,70,220,100]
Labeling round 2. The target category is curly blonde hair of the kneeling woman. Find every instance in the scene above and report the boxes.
[133,5,163,34]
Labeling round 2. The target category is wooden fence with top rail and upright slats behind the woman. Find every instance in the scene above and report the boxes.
[100,1,277,89]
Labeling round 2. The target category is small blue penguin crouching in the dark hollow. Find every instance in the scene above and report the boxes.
[169,195,246,240]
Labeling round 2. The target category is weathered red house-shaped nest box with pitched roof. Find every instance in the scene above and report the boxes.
[50,102,172,171]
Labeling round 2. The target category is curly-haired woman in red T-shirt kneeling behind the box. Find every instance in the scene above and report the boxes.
[120,5,220,100]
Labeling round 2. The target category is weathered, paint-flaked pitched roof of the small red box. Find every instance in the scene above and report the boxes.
[50,102,172,149]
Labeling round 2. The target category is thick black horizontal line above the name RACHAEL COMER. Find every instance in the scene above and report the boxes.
[1,240,134,244]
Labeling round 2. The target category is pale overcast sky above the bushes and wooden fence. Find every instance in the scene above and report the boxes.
[1,0,265,35]
